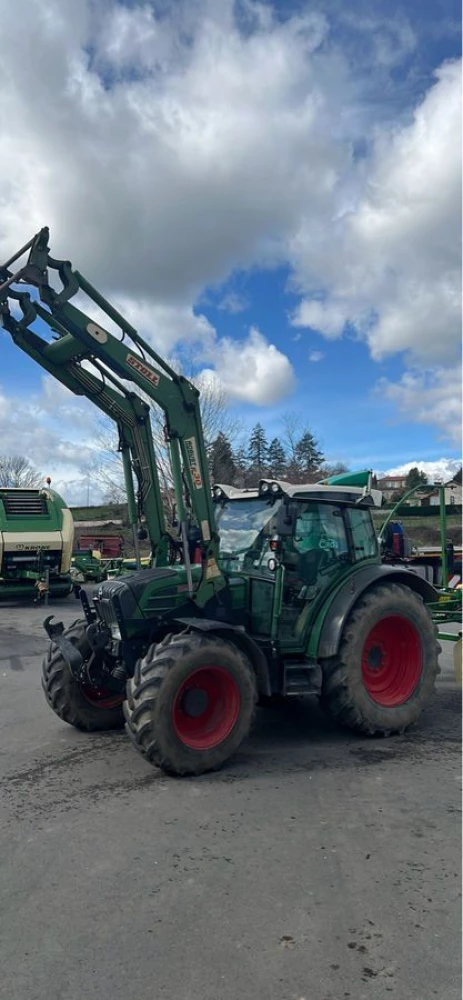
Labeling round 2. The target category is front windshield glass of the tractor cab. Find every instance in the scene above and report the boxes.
[215,500,281,572]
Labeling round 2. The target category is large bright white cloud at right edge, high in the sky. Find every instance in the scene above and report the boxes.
[292,62,461,365]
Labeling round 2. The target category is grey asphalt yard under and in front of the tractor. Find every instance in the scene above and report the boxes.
[0,598,461,1000]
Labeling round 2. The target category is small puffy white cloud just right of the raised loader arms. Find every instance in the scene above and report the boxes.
[202,328,295,406]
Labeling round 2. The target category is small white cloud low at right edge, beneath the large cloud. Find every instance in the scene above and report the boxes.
[377,365,462,446]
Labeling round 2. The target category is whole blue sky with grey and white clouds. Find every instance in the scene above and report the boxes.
[0,0,461,501]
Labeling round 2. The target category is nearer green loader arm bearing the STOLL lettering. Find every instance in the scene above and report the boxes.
[0,229,226,607]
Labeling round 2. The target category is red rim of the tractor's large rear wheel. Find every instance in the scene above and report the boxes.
[362,615,423,708]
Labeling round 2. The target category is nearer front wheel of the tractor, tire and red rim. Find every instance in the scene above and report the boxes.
[124,632,257,776]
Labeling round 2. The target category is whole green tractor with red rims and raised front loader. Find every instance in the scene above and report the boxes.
[0,229,446,775]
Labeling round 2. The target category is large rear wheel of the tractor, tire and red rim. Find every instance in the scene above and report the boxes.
[321,583,441,736]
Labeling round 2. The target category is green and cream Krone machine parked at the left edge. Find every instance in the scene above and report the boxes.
[0,483,74,601]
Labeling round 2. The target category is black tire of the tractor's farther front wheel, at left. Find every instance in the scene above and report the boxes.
[42,618,124,733]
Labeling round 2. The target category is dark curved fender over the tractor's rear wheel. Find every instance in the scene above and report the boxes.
[312,566,439,660]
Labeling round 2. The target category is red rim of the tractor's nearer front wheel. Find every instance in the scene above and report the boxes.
[172,666,241,750]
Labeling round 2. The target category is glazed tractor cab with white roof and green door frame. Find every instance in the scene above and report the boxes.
[213,480,379,651]
